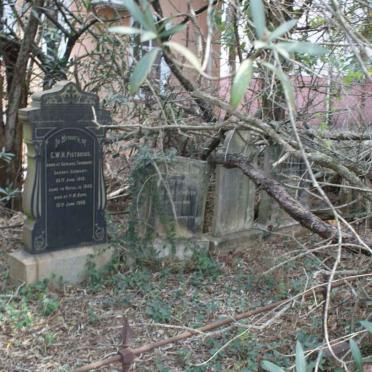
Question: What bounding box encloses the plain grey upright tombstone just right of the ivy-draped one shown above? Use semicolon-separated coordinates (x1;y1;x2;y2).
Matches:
212;131;256;236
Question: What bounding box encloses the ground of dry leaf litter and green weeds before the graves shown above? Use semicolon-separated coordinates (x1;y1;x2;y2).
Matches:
0;205;372;372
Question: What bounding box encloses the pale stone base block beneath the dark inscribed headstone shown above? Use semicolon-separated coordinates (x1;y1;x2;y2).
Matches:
8;244;113;284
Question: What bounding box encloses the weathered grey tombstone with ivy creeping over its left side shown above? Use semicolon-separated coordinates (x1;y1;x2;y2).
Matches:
141;156;209;258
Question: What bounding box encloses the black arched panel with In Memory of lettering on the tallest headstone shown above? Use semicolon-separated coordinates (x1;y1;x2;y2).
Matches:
45;128;95;245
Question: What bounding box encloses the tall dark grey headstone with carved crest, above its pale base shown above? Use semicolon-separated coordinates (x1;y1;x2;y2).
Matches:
20;81;110;253
